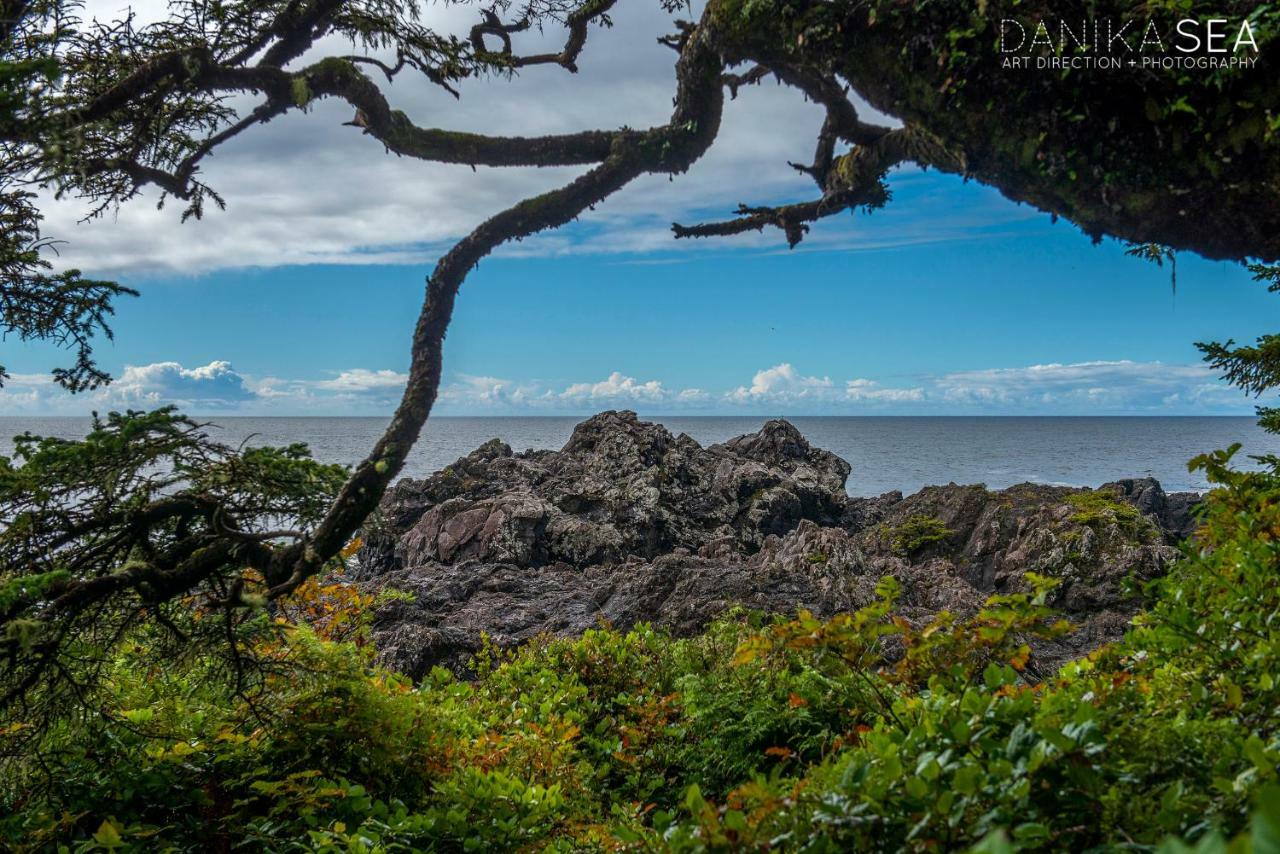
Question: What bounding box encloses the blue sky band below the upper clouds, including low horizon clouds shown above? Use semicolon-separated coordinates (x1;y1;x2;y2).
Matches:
4;167;1276;415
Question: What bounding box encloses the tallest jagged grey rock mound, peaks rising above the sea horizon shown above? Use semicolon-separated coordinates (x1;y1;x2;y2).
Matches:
360;412;849;576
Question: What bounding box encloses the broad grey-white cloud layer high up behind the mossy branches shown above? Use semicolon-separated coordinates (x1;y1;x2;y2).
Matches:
30;0;1033;275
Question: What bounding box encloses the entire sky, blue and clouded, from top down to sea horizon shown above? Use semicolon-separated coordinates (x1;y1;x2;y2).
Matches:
0;0;1280;415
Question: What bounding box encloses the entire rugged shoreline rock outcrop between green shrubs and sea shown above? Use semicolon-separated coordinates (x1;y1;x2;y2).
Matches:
357;411;1199;677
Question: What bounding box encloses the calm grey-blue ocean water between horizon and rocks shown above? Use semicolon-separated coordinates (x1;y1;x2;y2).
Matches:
0;415;1280;495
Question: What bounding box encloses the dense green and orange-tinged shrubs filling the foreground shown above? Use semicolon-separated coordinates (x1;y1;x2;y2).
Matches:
0;437;1280;851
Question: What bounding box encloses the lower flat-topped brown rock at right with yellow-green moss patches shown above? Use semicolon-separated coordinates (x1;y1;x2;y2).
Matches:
839;479;1198;668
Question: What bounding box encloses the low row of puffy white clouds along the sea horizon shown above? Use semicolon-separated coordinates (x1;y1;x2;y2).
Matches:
0;360;1253;415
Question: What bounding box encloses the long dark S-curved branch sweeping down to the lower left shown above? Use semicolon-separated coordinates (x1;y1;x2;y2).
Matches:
0;5;724;708
